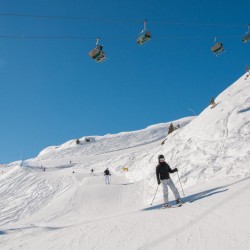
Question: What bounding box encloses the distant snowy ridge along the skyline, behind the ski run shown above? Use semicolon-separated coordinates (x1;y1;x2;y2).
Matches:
35;117;193;160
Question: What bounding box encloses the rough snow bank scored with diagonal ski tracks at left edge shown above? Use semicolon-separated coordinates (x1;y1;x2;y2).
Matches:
0;167;74;226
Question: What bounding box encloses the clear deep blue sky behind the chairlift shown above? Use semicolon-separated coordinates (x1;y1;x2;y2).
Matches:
0;0;250;163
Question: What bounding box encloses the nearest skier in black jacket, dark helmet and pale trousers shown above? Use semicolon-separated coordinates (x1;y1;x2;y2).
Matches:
156;155;183;208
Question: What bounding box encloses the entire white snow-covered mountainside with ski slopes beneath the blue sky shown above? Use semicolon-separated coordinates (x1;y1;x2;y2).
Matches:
0;75;250;250
